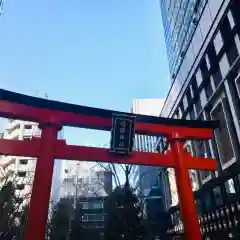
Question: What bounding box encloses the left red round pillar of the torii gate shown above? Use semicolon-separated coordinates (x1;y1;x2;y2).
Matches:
24;126;58;240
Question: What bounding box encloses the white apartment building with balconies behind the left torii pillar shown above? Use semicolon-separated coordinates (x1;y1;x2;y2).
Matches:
0;120;62;207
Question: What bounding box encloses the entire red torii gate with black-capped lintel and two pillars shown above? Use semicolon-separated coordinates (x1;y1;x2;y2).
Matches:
0;90;217;240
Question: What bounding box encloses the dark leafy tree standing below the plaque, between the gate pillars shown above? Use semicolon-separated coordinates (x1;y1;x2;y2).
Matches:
104;184;144;240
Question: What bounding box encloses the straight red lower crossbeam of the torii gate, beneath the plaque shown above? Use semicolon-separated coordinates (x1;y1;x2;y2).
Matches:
0;138;216;171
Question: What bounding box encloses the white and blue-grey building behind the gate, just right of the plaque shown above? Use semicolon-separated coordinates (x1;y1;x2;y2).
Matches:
131;99;164;197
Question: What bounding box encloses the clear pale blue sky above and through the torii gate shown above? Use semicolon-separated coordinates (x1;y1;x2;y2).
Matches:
0;0;170;145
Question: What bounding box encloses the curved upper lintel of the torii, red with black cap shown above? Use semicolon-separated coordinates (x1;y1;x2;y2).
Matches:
0;89;218;139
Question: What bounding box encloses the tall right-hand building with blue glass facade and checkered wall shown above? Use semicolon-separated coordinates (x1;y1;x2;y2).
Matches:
160;0;240;210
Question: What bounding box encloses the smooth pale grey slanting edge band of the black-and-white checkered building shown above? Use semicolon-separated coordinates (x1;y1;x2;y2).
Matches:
161;0;231;117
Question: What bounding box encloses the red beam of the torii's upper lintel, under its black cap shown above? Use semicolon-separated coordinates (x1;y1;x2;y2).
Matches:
0;101;212;139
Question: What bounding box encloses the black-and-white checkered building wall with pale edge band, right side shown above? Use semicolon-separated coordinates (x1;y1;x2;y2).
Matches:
161;0;240;208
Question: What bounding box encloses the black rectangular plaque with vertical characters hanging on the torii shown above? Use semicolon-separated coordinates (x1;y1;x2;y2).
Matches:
110;114;136;155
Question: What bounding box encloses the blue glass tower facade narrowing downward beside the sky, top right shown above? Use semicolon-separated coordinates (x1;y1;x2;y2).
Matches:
160;0;207;79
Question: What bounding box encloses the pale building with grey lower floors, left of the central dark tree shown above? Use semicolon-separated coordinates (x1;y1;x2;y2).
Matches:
60;162;112;239
